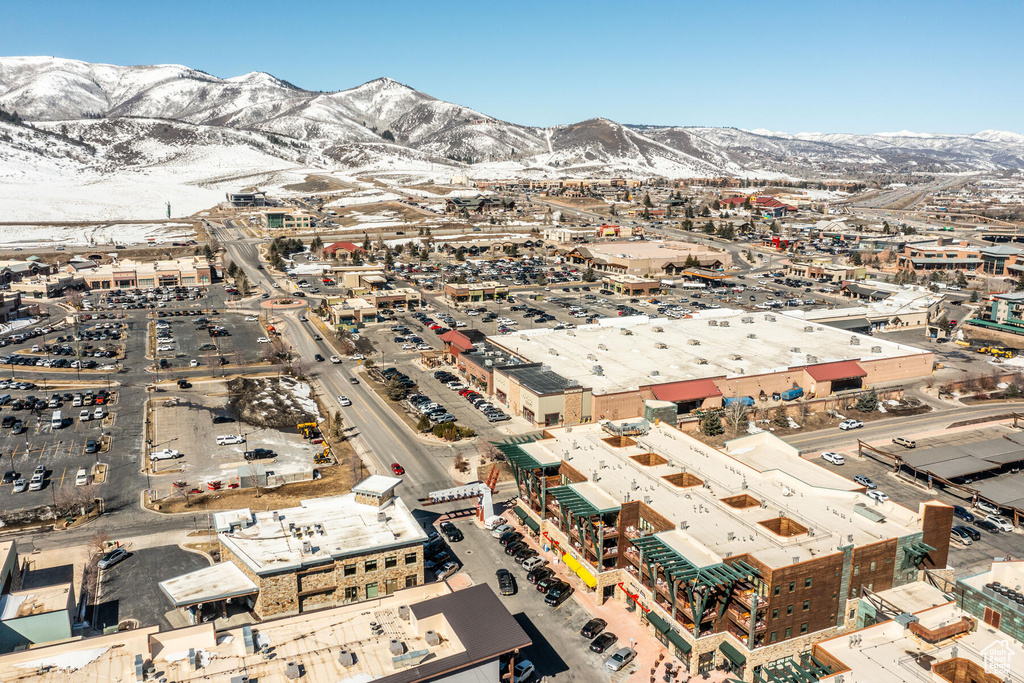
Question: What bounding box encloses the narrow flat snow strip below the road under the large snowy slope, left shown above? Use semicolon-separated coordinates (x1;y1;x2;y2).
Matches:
0;223;196;249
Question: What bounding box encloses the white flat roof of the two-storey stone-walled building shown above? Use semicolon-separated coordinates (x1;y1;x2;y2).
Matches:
219;493;427;574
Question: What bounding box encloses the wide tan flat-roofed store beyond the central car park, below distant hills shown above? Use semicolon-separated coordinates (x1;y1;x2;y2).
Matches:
565;240;732;278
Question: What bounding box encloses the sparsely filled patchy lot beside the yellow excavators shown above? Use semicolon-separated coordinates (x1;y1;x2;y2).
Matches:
151;381;323;494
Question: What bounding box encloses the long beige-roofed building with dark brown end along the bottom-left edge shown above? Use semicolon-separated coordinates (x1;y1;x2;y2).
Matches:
0;583;531;683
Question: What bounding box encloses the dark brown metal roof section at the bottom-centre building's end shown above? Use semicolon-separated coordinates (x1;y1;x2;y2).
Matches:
376;584;532;683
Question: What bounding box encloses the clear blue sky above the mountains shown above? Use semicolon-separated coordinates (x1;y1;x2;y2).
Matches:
0;0;1024;133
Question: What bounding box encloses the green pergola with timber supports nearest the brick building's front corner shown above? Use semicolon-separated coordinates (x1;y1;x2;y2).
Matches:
631;536;761;638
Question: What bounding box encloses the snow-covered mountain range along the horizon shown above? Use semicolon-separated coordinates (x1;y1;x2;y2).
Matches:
0;57;1024;196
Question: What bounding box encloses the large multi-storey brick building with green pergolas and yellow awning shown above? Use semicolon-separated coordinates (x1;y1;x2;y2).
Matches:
499;420;952;680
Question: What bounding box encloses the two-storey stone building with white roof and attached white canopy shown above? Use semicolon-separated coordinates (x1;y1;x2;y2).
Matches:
160;474;427;621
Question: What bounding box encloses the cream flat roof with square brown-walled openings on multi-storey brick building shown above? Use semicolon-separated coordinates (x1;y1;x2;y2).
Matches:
521;423;922;567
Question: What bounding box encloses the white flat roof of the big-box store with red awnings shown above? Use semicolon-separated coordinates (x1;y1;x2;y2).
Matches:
488;309;930;394
